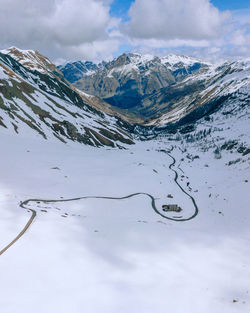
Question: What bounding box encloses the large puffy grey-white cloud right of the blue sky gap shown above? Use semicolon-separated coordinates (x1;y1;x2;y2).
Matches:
124;0;229;40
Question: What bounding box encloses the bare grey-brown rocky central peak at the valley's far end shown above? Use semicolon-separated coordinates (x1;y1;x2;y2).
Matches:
66;54;178;109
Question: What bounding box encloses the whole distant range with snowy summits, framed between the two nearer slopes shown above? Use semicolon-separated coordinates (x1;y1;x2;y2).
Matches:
59;53;208;115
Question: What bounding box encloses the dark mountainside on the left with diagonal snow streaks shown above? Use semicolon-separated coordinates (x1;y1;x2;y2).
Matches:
0;48;133;147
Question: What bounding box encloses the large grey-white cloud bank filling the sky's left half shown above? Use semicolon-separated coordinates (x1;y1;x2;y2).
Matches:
0;0;118;59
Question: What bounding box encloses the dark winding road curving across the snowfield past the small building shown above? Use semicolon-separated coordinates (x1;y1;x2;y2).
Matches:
0;147;199;255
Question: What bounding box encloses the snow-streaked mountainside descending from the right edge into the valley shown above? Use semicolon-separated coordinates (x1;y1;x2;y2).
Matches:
146;60;250;126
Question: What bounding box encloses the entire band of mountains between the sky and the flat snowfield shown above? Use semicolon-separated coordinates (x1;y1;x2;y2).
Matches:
0;47;250;147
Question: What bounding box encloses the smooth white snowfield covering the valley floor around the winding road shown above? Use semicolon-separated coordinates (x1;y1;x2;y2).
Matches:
0;125;250;313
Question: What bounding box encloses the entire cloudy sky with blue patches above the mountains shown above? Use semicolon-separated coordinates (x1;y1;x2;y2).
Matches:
0;0;250;63
